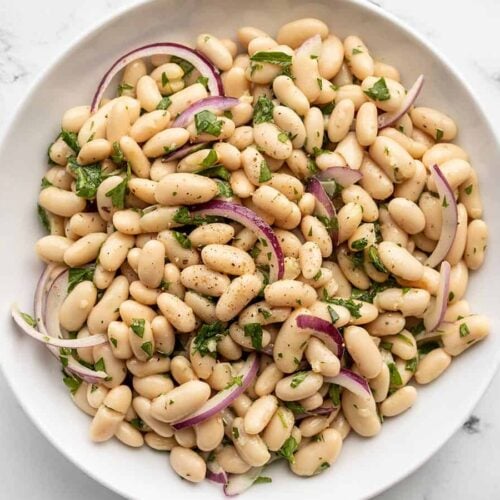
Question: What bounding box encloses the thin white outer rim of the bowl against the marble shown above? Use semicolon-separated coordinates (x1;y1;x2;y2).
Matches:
0;0;500;498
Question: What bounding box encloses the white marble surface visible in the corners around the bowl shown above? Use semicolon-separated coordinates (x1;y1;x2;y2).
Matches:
0;0;500;500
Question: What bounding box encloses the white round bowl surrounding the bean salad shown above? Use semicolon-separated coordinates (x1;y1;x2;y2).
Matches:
0;0;500;500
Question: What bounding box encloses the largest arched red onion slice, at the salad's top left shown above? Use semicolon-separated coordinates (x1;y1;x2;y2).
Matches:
90;42;224;113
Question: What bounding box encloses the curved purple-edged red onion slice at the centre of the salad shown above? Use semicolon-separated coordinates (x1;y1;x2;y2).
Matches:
193;200;285;283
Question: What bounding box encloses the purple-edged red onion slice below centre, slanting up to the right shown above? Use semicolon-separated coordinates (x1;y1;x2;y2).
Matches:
172;353;259;430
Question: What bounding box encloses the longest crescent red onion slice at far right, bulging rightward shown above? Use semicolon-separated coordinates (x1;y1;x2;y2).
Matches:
425;165;458;267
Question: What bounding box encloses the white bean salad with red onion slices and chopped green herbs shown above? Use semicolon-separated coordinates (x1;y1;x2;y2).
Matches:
12;19;489;495
